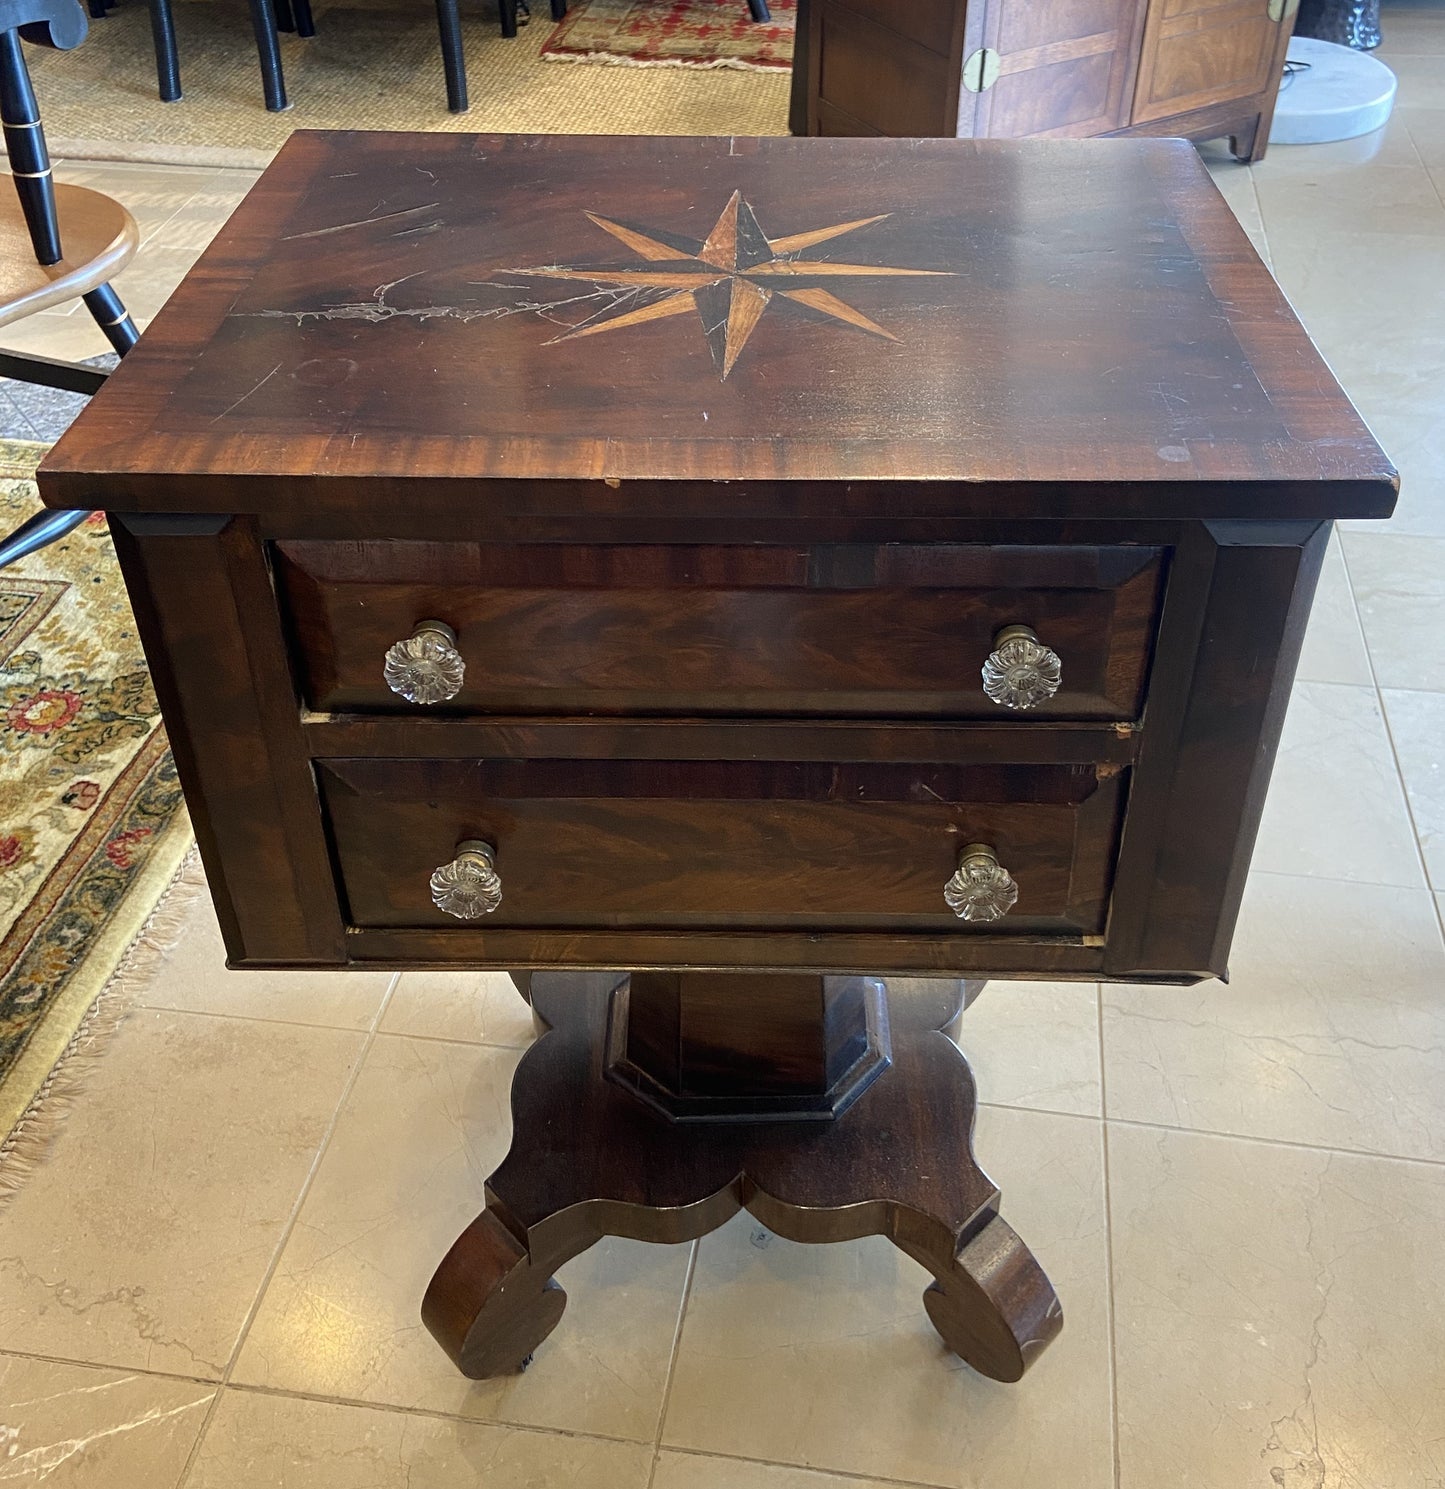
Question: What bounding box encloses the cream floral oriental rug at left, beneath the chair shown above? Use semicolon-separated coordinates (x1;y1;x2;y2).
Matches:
0;439;191;1154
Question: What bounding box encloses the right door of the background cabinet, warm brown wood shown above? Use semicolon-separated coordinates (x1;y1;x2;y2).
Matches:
1134;0;1280;124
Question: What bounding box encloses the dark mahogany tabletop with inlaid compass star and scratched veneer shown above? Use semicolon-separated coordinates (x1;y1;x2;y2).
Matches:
42;131;1394;517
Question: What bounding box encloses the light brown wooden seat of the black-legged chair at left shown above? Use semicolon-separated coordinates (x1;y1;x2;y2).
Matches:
0;185;140;326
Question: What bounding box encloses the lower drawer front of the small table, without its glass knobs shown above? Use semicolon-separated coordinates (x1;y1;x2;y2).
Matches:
317;759;1128;935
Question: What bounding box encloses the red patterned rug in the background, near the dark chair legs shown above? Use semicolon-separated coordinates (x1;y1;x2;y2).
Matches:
533;0;797;71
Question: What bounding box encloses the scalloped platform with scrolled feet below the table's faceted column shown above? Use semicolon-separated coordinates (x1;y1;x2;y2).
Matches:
422;972;1062;1380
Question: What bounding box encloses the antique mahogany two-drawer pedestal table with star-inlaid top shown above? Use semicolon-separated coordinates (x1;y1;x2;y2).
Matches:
40;133;1394;1380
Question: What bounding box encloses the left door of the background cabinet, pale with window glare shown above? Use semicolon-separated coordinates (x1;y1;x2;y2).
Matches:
961;0;1144;138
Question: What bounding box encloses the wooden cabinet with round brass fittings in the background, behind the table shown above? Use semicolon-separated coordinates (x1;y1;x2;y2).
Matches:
793;0;1295;159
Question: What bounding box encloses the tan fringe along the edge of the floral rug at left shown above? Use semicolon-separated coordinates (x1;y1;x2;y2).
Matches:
0;843;206;1205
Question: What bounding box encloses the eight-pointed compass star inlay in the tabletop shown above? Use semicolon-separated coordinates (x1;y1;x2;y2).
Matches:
488;192;950;378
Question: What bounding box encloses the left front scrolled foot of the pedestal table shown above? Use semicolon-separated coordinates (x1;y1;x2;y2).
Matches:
422;1209;580;1380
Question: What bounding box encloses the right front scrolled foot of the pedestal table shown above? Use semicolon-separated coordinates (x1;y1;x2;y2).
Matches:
924;1215;1064;1382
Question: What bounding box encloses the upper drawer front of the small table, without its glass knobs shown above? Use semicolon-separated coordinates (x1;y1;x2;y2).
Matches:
276;541;1163;719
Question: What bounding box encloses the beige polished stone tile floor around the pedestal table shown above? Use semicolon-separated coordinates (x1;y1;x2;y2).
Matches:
0;6;1445;1489
